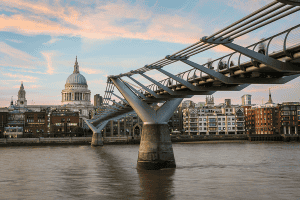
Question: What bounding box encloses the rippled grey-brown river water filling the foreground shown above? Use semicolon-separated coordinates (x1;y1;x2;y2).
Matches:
0;142;300;200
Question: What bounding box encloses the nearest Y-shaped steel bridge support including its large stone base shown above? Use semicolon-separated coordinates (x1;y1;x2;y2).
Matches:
111;78;183;170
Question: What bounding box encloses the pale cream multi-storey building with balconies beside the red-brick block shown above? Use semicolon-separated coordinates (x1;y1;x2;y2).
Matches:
183;97;245;135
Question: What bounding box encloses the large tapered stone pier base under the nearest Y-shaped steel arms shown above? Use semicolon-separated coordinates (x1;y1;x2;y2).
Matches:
137;122;176;170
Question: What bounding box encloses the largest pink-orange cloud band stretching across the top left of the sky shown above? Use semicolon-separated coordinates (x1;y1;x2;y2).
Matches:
0;0;202;44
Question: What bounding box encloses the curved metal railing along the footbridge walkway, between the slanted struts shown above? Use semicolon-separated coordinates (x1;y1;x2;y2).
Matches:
140;25;300;94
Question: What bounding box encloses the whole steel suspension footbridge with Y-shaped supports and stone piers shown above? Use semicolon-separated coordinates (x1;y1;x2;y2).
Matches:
85;0;300;169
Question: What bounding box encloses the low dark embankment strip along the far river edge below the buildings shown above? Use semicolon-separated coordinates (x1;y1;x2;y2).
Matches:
0;135;300;147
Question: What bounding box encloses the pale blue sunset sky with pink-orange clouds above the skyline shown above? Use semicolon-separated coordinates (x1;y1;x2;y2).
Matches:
0;0;300;107
